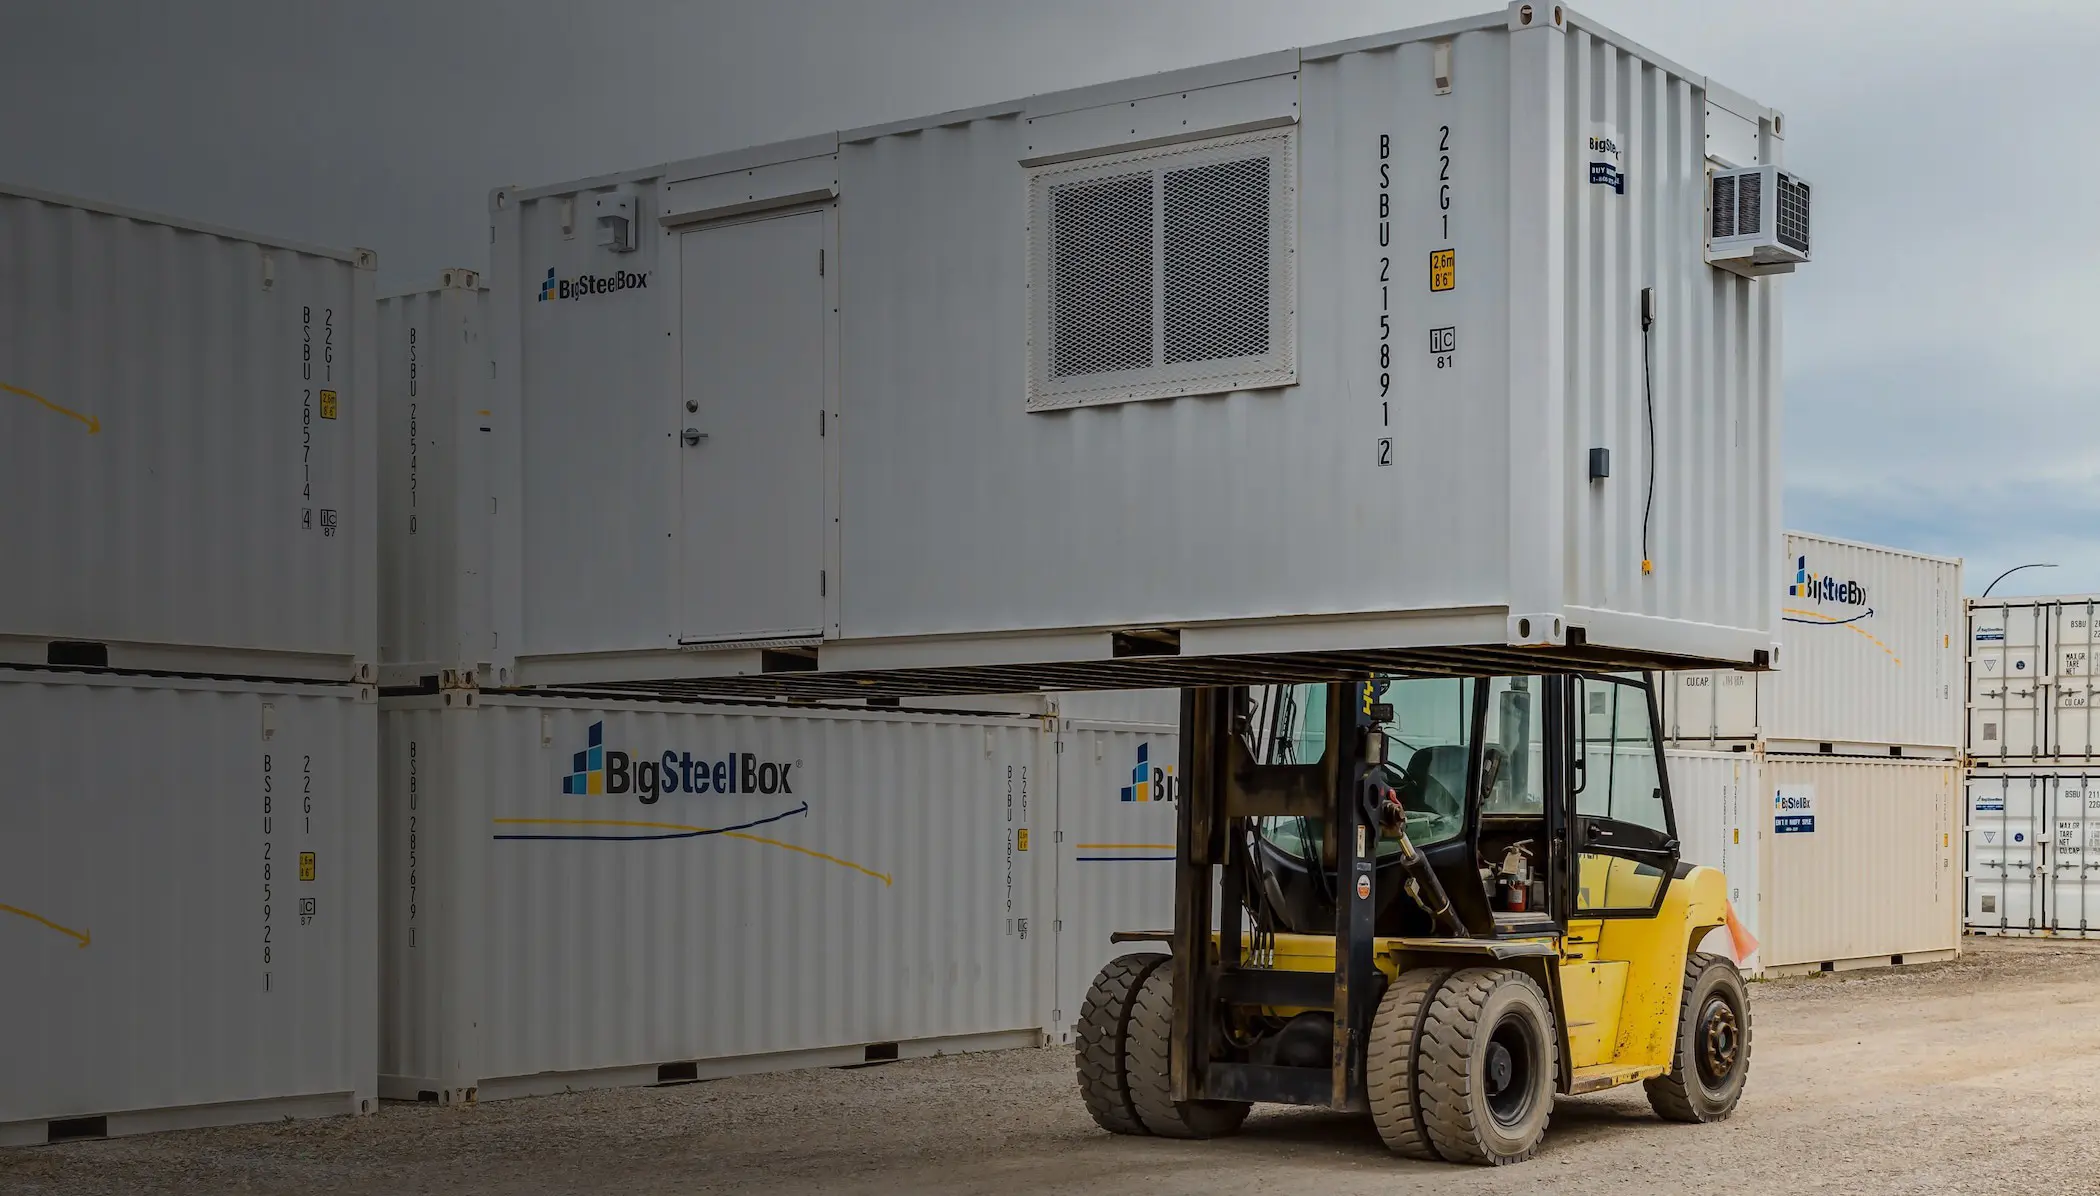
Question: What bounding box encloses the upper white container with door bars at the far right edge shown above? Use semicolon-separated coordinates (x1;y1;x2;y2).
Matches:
1968;594;2100;768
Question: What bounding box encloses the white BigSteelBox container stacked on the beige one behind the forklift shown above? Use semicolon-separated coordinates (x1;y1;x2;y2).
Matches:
1661;531;1964;755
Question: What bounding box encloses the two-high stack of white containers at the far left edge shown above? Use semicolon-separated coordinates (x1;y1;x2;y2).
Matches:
0;187;378;1144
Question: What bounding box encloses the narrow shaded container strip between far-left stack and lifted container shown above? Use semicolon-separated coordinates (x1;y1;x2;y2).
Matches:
378;271;493;684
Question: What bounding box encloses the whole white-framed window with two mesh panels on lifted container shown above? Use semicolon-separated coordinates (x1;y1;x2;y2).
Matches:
1029;130;1296;409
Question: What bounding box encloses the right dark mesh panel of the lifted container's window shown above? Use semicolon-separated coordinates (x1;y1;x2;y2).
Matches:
1159;155;1271;363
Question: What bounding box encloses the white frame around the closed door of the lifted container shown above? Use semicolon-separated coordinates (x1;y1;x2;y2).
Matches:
657;196;844;648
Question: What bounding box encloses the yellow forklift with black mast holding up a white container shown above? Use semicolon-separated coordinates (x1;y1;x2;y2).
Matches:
1077;674;1749;1165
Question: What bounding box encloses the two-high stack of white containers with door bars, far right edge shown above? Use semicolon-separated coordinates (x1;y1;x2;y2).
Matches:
1964;594;2100;938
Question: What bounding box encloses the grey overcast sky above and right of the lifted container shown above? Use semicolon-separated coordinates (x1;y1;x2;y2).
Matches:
0;0;2100;594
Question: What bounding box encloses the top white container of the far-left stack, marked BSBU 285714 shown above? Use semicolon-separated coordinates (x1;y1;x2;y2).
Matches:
0;187;378;680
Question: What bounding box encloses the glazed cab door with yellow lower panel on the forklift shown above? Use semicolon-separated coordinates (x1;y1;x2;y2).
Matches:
1569;678;1678;919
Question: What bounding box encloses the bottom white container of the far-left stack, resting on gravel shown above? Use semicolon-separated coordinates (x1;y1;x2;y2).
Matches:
0;671;378;1146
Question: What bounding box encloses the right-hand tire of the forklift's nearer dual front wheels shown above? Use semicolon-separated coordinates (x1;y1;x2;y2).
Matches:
1415;967;1560;1167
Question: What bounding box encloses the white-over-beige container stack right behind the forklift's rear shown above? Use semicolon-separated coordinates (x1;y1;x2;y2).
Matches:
1663;533;1964;974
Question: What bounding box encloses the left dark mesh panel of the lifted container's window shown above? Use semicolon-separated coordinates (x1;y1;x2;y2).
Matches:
1050;172;1153;378
